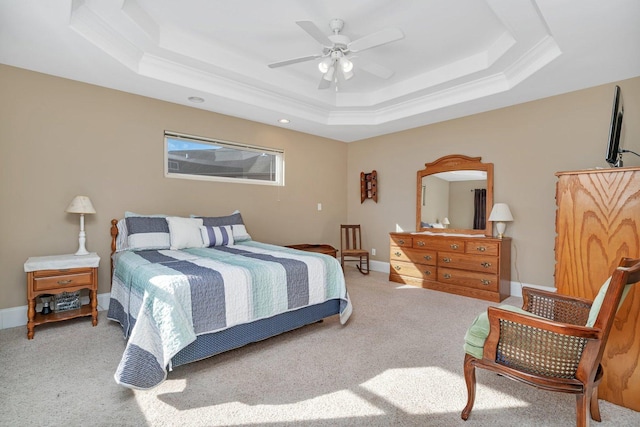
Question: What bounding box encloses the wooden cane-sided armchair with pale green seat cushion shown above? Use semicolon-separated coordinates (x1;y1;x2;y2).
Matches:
462;258;640;427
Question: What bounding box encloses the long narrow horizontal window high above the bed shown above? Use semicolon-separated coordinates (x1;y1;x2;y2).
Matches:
164;132;284;186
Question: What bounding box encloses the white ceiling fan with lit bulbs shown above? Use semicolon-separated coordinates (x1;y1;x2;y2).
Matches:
269;19;404;89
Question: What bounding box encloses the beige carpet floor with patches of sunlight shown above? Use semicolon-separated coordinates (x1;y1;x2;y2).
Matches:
0;269;640;427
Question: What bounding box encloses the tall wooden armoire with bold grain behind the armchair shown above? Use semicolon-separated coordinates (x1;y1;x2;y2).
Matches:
555;167;640;411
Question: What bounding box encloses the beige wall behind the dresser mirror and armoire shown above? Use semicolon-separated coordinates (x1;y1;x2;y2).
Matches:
347;78;640;286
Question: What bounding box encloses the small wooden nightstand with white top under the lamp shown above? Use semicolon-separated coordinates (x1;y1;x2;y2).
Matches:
24;252;100;339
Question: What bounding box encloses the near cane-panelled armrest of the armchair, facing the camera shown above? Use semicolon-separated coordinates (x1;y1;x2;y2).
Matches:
483;307;601;378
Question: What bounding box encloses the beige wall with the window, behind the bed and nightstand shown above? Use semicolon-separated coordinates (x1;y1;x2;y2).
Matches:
0;65;347;309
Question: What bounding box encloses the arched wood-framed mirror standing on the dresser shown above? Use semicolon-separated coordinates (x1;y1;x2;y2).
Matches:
416;154;493;236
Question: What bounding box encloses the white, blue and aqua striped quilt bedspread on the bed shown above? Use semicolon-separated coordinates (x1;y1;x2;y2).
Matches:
108;241;352;389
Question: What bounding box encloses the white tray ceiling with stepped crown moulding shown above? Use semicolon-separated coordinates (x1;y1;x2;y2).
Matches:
0;0;640;142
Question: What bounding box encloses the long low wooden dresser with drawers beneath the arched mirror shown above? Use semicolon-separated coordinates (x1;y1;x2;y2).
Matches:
389;233;511;302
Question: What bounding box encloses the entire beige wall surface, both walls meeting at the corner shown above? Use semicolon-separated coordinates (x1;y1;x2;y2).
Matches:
0;65;640;309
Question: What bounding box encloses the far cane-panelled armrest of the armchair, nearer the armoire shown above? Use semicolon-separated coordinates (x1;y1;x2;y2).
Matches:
522;287;592;326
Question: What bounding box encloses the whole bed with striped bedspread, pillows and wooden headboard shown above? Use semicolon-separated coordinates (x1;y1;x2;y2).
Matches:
107;212;352;389
